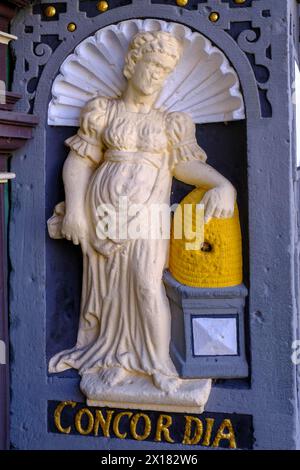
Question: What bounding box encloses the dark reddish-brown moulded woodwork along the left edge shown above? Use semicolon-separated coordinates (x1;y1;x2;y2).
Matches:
0;0;38;450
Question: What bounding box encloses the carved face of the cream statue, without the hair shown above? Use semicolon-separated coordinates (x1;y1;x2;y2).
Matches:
131;52;177;95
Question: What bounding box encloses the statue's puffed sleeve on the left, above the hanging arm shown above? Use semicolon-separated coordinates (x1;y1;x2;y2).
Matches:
65;97;108;166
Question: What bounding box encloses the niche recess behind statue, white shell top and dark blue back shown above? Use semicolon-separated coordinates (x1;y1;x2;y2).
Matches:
37;19;248;375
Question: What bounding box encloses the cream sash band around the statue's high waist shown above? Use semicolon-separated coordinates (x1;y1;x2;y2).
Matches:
104;149;164;169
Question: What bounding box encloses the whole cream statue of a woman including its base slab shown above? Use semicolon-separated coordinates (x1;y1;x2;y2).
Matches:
48;22;241;412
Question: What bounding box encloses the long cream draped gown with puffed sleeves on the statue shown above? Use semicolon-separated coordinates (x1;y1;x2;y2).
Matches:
49;97;206;377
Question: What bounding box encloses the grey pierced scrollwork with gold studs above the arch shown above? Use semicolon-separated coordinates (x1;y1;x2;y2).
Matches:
12;0;273;117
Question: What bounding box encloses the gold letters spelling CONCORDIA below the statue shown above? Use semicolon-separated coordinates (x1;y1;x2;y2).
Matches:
54;401;237;449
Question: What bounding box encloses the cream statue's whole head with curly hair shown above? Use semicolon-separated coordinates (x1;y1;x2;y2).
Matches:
124;31;182;95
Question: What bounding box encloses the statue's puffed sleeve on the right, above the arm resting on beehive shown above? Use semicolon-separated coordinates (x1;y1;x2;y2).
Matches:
167;112;207;170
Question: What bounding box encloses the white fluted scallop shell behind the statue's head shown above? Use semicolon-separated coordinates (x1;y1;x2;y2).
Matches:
48;19;245;126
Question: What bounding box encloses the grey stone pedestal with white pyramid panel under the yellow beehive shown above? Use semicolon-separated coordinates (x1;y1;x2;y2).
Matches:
164;271;248;378
